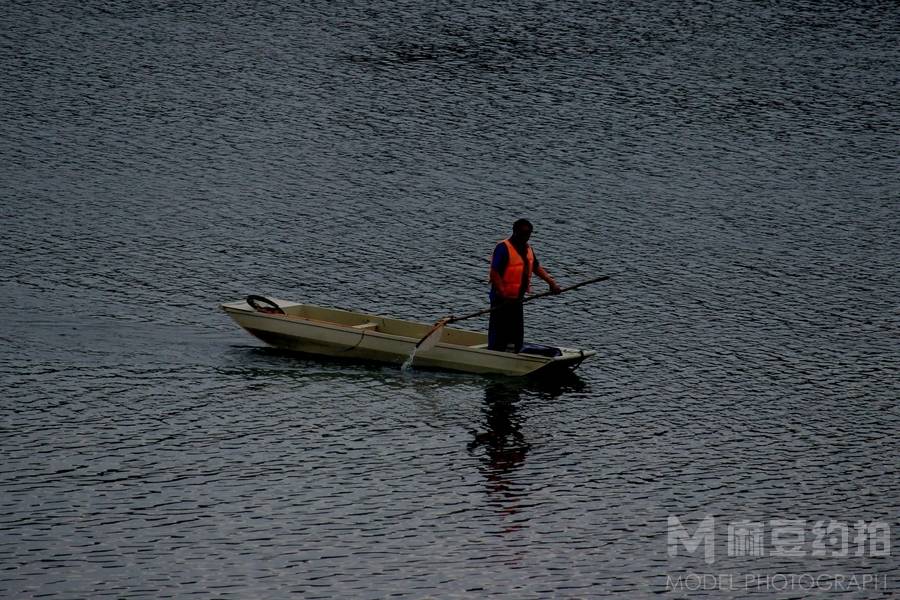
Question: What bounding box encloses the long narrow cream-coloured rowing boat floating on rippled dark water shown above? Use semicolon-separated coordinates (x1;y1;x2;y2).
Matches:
222;296;596;376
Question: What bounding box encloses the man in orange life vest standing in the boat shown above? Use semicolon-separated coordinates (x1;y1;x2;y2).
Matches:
488;219;561;352
